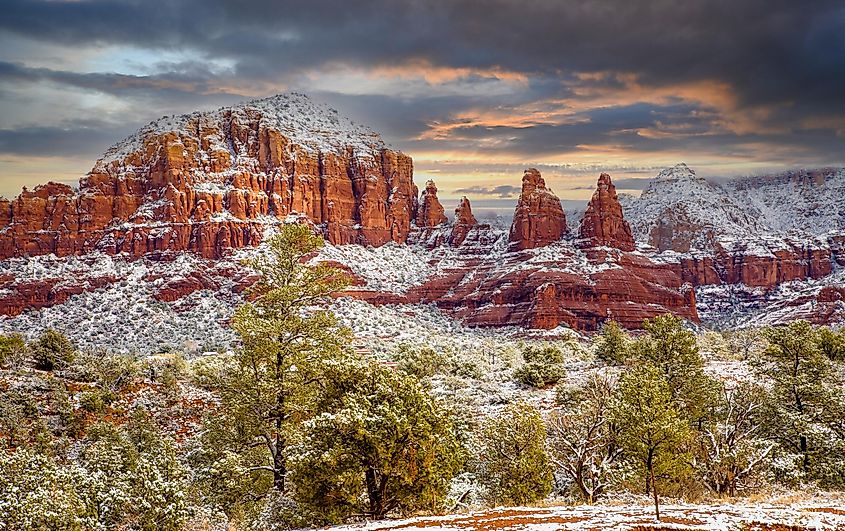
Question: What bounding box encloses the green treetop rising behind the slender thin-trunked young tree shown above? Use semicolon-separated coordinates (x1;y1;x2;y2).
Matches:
631;314;718;422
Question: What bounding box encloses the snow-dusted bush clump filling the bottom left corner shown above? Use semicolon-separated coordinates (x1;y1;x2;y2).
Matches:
0;415;189;531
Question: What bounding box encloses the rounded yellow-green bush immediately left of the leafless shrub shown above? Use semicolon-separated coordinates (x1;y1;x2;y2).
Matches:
478;403;552;505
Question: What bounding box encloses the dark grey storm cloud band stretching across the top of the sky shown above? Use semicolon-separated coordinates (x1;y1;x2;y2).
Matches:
6;0;845;112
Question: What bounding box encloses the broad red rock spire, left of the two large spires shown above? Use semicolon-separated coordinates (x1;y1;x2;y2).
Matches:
509;168;566;250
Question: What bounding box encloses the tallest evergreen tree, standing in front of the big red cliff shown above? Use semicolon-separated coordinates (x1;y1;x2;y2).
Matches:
197;224;351;510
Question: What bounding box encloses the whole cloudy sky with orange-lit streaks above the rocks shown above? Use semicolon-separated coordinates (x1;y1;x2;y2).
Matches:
0;0;845;202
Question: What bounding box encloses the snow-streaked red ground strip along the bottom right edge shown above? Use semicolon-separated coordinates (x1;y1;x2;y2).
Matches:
333;499;845;531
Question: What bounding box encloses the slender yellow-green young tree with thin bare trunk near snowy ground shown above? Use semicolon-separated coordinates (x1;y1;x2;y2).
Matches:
611;364;690;520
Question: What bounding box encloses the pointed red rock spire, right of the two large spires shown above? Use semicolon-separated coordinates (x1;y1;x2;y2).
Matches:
580;173;636;251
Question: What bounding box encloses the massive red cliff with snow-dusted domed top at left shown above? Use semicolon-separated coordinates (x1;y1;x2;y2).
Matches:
0;94;417;258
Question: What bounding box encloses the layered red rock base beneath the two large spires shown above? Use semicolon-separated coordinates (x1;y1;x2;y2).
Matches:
340;244;698;330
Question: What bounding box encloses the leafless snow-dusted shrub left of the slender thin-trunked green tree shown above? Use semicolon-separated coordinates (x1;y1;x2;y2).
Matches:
548;376;622;503
